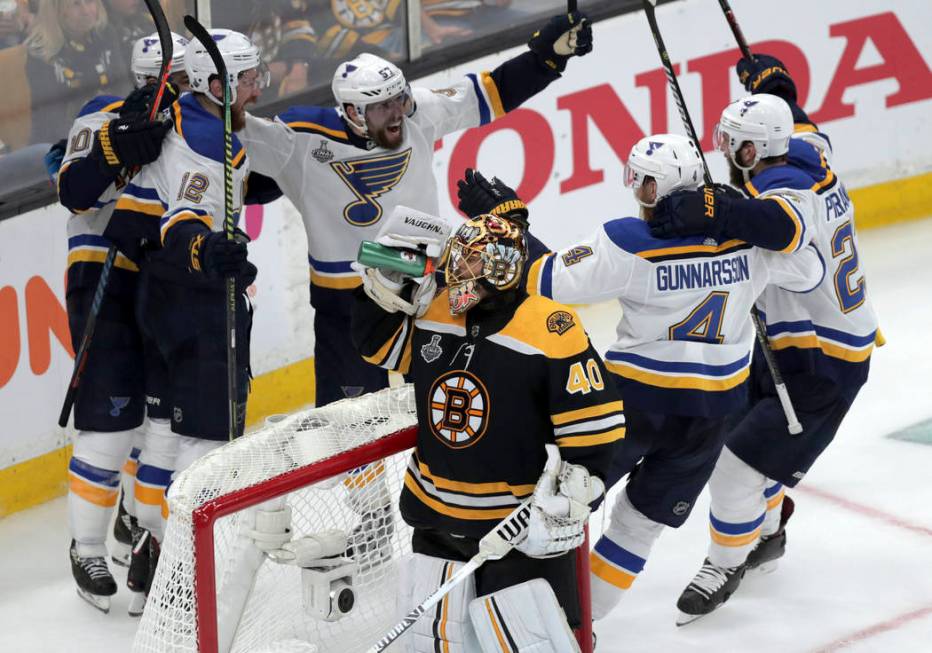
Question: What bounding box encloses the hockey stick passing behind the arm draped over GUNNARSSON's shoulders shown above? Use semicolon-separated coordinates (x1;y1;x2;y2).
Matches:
642;0;803;435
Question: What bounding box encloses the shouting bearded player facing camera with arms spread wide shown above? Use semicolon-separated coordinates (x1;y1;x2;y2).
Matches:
243;12;592;405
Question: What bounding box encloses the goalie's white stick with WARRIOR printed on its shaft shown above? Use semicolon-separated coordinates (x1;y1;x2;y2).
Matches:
366;444;560;653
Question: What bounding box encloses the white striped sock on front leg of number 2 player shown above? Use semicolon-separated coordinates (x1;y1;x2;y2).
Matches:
709;447;768;567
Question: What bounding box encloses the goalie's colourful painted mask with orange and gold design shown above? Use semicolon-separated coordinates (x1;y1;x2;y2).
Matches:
444;214;527;315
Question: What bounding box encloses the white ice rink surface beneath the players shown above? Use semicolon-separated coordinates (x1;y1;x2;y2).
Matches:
0;220;932;653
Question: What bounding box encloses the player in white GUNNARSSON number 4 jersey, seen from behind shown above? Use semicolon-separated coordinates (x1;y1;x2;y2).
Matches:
458;134;824;619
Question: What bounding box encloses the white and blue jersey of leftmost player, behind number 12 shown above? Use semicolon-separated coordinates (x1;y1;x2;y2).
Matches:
58;95;139;293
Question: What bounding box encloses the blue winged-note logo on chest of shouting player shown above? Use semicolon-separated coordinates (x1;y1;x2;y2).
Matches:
330;148;411;227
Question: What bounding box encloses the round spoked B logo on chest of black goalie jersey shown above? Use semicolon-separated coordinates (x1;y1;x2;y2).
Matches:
428;370;491;449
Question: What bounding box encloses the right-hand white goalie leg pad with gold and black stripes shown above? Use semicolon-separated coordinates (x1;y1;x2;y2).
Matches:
469;578;579;653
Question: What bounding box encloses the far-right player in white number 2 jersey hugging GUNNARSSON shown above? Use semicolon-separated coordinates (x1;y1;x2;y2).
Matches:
658;55;883;623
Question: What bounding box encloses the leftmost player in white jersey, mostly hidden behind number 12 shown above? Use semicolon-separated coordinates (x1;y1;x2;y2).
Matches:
57;34;187;612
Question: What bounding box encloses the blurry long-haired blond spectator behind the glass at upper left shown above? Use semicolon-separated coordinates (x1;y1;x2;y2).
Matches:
26;0;129;143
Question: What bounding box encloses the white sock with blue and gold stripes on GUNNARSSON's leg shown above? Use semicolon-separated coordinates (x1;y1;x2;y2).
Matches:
589;490;663;619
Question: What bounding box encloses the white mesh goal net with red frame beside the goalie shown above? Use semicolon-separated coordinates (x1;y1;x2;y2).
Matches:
133;386;416;653
